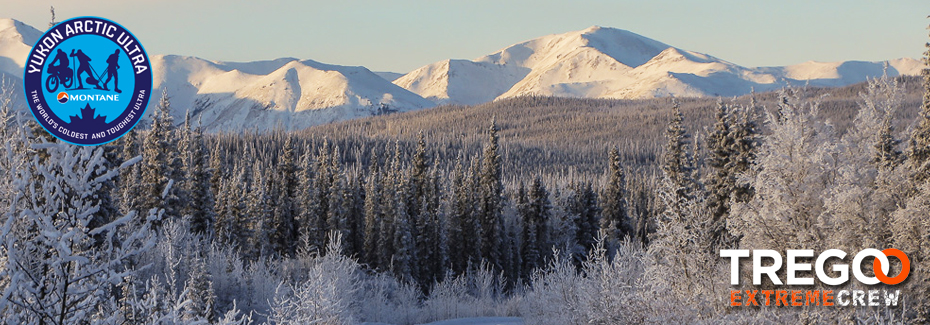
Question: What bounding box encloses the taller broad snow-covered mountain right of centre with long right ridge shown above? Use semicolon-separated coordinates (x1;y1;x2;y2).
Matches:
394;26;921;104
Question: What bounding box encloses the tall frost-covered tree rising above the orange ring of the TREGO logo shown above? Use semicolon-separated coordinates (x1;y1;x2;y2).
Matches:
821;75;906;249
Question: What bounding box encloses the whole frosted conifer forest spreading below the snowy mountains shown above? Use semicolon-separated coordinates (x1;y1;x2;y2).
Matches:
0;30;930;324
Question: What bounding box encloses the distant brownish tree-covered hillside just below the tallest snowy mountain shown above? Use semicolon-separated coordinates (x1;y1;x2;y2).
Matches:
301;77;921;174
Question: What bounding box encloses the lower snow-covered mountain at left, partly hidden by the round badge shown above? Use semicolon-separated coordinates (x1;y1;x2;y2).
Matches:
0;19;435;131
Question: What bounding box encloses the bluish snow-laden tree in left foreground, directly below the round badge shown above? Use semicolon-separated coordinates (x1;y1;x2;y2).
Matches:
0;143;161;324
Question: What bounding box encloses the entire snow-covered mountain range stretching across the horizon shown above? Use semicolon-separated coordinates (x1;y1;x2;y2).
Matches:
0;19;922;131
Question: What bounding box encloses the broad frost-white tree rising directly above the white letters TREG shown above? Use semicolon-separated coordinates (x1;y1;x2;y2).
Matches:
728;91;840;250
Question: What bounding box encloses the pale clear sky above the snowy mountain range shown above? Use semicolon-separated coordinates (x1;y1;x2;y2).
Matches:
0;0;930;72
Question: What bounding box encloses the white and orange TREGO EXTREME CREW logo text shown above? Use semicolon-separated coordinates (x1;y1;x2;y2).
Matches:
720;248;911;306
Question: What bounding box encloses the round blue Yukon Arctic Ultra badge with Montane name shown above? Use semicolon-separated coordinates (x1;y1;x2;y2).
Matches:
23;17;152;146
